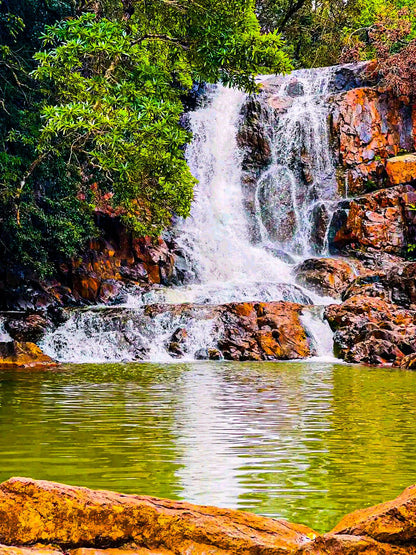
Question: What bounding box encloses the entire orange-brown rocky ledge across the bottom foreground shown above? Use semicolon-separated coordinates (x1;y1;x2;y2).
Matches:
0;478;416;555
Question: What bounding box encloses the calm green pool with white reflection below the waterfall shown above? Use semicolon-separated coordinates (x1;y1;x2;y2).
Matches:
0;362;416;531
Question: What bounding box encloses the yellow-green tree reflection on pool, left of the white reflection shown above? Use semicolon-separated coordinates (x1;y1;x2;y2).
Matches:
0;365;186;498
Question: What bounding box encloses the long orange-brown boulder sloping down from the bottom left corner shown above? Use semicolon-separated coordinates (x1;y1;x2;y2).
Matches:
0;478;315;555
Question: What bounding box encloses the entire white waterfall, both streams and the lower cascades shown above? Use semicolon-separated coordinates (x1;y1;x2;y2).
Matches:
42;68;344;362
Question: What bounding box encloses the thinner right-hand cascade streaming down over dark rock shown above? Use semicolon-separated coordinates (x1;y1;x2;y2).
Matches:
250;68;337;256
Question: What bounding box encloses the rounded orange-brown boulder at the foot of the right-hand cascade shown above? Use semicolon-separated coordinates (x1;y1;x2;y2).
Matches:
294;258;355;298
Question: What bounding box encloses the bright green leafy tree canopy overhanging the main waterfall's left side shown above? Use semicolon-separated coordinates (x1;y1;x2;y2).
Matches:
33;0;291;235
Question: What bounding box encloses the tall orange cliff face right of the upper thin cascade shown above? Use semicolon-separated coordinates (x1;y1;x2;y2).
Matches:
331;87;416;195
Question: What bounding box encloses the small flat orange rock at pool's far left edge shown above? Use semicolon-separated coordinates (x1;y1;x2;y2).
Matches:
0;341;57;370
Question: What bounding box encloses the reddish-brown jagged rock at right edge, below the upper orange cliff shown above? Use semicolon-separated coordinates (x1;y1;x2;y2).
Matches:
333;185;416;255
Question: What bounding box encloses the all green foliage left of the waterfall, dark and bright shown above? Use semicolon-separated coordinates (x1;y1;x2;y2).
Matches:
0;0;291;273
